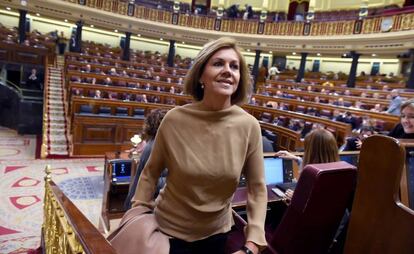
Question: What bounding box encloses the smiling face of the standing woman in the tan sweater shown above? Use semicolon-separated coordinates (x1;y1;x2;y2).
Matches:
200;48;240;104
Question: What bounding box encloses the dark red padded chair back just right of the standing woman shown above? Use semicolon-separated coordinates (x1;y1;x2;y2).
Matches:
269;161;357;254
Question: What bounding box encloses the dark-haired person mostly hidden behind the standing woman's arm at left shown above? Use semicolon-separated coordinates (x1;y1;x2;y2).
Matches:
124;109;168;210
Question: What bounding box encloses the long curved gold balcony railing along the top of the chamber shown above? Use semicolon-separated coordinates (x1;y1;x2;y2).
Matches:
64;0;414;36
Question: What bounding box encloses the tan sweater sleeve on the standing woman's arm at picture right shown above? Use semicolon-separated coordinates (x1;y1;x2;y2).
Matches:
244;122;267;249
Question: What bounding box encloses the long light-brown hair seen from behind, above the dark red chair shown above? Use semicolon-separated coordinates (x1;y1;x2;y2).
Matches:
302;129;339;168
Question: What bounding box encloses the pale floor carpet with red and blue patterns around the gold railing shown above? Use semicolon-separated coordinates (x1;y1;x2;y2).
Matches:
0;127;104;253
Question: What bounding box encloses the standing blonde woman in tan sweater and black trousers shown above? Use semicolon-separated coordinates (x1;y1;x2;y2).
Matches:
133;38;267;254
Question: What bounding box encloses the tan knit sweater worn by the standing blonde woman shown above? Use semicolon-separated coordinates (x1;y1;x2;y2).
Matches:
133;102;267;246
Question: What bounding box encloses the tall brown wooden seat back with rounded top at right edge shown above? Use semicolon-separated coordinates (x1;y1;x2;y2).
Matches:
344;135;414;254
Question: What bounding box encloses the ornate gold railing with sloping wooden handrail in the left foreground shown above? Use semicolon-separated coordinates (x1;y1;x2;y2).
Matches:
42;165;116;254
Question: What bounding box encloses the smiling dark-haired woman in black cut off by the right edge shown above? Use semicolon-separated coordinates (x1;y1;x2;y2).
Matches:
388;99;414;139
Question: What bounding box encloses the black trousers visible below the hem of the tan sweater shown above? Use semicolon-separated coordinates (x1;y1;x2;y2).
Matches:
170;233;228;254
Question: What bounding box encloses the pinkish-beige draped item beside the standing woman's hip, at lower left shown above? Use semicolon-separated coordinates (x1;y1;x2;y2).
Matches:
107;206;170;254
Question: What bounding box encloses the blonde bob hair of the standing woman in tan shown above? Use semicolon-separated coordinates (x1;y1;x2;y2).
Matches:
184;37;251;105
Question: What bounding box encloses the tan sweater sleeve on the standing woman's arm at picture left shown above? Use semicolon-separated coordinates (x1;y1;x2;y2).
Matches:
132;123;167;208
